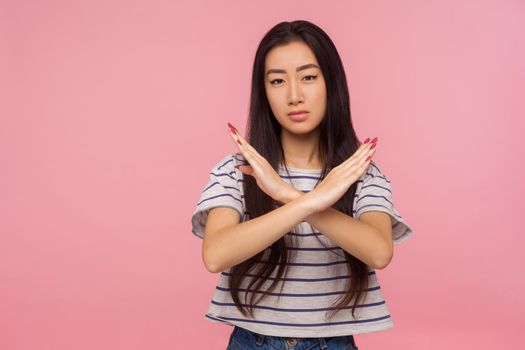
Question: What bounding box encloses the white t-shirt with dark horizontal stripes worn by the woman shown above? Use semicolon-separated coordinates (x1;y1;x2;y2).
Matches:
191;153;412;337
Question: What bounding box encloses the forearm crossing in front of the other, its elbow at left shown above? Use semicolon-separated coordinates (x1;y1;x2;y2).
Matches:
204;197;313;272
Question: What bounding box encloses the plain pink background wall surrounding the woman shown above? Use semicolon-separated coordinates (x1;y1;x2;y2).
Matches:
0;0;525;350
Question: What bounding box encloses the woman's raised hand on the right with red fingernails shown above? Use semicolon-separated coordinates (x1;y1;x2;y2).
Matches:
305;138;377;212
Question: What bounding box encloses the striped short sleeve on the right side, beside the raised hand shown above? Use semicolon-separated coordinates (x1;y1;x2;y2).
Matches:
354;161;412;245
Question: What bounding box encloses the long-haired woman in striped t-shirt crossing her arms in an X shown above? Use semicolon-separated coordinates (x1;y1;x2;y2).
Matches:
192;21;412;349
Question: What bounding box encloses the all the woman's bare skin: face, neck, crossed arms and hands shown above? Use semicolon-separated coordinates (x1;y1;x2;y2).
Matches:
202;43;393;272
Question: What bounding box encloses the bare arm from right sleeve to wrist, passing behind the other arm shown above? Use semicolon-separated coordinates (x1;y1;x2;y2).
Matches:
280;189;393;269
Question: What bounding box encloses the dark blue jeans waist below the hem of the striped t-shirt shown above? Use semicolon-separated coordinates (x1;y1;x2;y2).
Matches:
226;326;357;350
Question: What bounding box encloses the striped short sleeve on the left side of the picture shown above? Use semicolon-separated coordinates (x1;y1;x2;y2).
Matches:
191;154;244;238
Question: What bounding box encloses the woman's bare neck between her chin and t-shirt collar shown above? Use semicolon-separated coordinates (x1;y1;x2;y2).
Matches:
281;129;322;169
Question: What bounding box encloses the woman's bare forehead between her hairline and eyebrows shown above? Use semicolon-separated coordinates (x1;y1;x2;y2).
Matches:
264;42;319;71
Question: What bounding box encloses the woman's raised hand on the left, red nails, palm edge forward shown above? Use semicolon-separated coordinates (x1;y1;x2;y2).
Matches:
228;123;296;203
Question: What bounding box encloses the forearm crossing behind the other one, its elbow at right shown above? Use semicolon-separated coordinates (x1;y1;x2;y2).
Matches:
281;191;389;269
